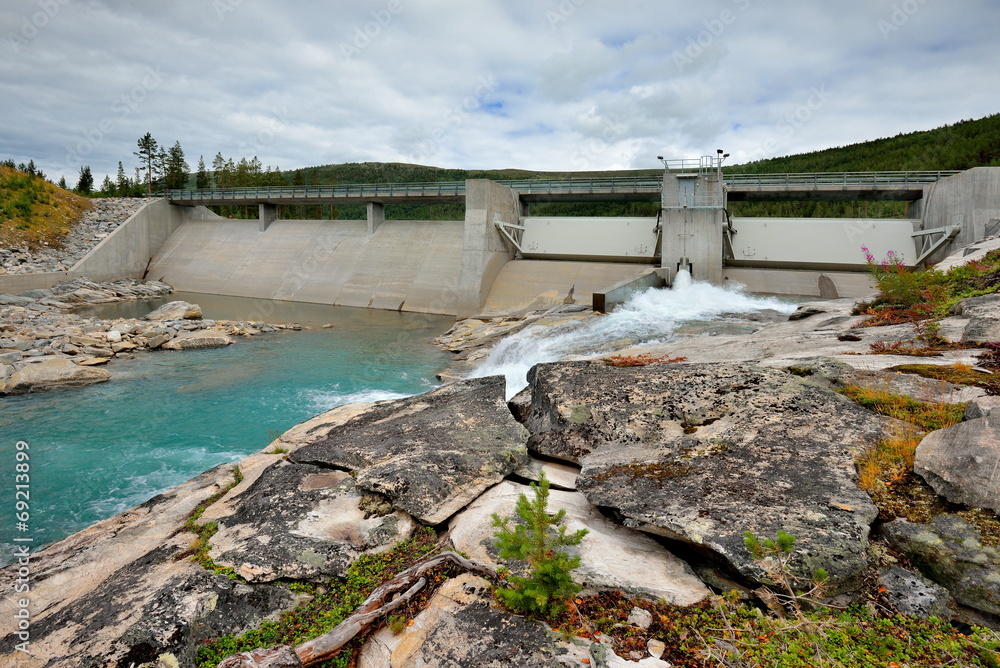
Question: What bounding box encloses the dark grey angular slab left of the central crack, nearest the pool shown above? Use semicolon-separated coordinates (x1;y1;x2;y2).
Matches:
290;376;528;524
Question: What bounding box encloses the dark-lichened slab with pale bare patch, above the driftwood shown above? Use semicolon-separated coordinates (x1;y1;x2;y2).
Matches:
209;461;416;582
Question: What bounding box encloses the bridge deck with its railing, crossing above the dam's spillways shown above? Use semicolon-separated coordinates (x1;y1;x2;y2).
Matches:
166;171;958;206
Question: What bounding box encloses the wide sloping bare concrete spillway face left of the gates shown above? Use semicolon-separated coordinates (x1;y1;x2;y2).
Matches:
148;219;463;315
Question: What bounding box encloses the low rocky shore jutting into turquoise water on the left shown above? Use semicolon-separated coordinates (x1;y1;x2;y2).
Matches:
0;279;301;395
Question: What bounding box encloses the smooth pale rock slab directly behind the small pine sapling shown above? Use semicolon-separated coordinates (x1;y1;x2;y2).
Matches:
449;481;710;605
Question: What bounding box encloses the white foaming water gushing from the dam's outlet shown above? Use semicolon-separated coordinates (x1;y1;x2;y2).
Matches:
470;270;795;399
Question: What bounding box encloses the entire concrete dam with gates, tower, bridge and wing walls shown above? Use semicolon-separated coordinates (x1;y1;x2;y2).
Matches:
0;163;1000;317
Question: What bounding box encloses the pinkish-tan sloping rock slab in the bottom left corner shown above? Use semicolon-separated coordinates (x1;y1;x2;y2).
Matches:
0;465;294;668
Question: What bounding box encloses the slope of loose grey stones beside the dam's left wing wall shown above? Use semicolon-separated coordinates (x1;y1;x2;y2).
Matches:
0;197;149;274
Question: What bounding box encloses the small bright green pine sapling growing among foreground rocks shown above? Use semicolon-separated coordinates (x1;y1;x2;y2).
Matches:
493;473;588;619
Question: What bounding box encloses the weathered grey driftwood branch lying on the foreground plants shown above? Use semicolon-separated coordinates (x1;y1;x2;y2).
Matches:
218;552;497;668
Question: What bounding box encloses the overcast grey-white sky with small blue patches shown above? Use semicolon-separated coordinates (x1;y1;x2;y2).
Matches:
0;0;1000;185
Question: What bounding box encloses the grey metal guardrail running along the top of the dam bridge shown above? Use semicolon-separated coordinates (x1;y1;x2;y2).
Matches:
166;170;959;201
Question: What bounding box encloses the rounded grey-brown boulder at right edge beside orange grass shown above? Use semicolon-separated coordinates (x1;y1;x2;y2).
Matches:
913;409;1000;511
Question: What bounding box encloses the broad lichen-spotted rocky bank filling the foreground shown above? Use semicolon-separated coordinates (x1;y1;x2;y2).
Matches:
0;250;1000;668
